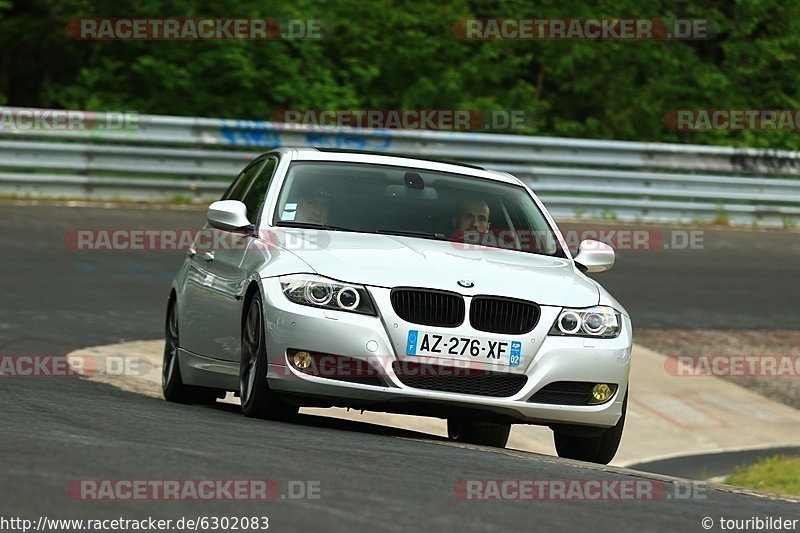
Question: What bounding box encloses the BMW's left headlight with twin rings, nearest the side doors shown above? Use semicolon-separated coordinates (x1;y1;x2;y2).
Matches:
279;274;376;315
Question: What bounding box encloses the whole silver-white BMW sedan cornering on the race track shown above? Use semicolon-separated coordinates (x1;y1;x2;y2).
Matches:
163;148;632;463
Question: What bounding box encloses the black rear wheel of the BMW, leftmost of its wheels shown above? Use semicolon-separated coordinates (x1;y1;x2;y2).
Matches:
161;298;222;404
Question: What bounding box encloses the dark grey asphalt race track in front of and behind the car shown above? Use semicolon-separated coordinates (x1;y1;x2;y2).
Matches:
0;204;800;531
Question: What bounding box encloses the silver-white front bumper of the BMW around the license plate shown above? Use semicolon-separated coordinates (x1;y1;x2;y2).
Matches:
262;278;632;427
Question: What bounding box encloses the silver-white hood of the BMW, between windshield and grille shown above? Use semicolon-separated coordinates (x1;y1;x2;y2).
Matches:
272;228;599;307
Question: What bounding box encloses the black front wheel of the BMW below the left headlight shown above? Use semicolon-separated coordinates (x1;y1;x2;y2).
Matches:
239;292;298;420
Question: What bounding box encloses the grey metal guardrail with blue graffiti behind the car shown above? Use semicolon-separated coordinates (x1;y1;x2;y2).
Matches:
0;107;800;227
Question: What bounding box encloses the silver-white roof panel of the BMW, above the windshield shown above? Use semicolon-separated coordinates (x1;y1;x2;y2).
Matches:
264;147;522;185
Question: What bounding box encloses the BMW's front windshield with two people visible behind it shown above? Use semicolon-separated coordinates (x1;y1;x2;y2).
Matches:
273;162;565;257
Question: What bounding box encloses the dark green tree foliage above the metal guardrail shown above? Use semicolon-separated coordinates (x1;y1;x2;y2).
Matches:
0;0;800;149
